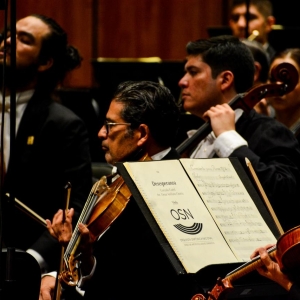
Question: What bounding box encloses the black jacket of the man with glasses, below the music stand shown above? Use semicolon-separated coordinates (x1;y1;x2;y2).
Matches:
78;149;199;300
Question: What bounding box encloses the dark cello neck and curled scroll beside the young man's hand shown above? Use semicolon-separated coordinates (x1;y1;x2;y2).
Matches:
176;63;299;158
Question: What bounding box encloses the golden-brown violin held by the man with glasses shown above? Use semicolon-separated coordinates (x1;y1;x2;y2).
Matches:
58;154;151;286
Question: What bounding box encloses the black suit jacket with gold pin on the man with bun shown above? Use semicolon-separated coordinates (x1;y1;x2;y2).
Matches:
2;93;92;269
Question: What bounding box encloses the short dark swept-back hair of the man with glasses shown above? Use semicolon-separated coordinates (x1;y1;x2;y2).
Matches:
114;81;180;147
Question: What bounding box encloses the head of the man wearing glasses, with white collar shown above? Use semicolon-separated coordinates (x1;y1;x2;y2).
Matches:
98;82;179;164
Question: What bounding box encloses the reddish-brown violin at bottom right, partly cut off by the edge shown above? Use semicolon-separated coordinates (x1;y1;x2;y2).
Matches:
192;226;300;300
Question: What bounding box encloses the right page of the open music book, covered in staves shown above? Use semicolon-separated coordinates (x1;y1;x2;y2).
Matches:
180;158;276;261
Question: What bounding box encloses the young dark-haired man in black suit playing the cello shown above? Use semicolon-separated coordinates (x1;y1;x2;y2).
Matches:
179;36;300;230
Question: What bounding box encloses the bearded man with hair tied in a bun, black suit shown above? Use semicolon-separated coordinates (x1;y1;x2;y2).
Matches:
0;15;92;272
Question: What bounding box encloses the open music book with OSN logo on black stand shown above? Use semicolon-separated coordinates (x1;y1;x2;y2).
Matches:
117;158;279;274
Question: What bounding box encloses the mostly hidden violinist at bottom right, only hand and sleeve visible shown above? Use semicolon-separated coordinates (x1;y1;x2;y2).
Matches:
250;245;300;300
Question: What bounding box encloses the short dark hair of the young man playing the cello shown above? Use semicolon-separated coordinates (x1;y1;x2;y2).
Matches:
186;35;255;93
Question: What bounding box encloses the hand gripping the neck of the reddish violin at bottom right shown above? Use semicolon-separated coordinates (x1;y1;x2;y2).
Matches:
250;245;293;291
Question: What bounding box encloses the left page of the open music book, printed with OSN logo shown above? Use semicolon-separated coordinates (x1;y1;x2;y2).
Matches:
124;160;239;273
